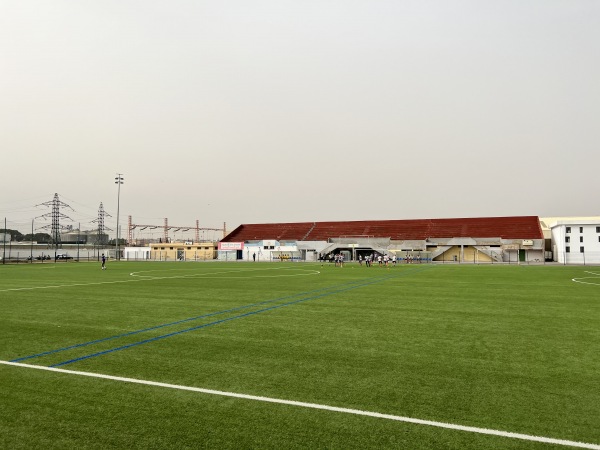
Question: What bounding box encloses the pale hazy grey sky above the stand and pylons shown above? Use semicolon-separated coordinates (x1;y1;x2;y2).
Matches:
0;0;600;243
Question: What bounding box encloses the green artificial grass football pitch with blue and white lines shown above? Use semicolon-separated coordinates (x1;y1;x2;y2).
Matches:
0;262;600;449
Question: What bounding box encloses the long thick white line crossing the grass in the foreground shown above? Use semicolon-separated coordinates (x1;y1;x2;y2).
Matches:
0;361;600;450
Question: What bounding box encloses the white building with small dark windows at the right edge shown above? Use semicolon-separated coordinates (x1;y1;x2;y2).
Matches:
548;218;600;264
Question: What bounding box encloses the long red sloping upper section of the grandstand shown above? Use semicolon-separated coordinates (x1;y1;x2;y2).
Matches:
223;216;544;242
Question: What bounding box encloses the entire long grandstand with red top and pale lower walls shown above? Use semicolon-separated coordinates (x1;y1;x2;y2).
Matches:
221;216;545;263
